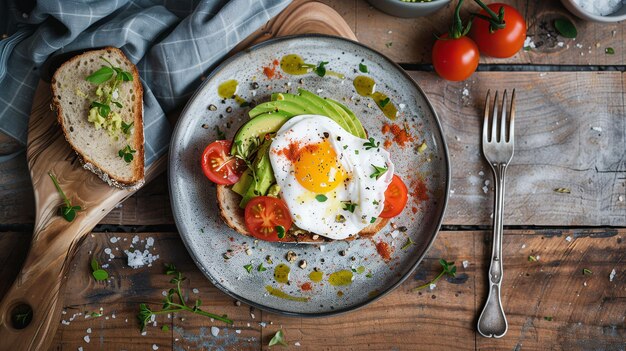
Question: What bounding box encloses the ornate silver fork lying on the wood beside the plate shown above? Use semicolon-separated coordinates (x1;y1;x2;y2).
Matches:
478;89;515;338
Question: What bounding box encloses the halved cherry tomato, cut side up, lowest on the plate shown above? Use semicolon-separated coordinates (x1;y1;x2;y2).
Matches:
244;196;292;241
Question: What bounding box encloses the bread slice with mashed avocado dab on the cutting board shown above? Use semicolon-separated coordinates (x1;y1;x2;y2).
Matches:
51;47;144;189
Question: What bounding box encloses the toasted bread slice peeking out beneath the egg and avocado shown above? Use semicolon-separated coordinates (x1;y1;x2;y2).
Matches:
217;185;389;243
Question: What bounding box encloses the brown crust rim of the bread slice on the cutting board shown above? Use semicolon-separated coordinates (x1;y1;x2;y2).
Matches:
51;47;145;190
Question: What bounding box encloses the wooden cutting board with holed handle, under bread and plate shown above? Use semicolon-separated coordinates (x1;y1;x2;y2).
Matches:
0;1;356;350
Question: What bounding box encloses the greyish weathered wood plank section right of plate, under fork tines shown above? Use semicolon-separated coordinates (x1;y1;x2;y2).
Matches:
411;72;626;226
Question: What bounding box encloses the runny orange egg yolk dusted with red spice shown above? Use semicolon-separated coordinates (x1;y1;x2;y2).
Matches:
294;140;346;194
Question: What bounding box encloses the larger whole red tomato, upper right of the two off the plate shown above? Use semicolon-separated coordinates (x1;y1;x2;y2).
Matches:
470;3;526;58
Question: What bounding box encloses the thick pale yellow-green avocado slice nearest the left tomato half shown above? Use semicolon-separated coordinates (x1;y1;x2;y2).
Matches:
230;111;292;156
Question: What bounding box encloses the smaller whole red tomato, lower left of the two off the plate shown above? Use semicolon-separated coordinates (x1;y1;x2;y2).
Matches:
433;34;480;81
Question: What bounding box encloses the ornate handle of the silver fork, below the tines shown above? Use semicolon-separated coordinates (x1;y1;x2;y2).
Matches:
478;163;509;338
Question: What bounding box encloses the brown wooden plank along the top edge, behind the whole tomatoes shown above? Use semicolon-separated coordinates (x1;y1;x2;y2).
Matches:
338;0;626;65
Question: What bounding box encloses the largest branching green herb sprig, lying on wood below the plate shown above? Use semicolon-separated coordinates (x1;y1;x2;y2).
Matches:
137;264;233;331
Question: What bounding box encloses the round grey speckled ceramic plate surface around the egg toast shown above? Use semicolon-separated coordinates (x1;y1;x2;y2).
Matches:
169;35;450;316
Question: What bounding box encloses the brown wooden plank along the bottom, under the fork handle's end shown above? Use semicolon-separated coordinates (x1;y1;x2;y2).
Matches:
30;229;626;350
